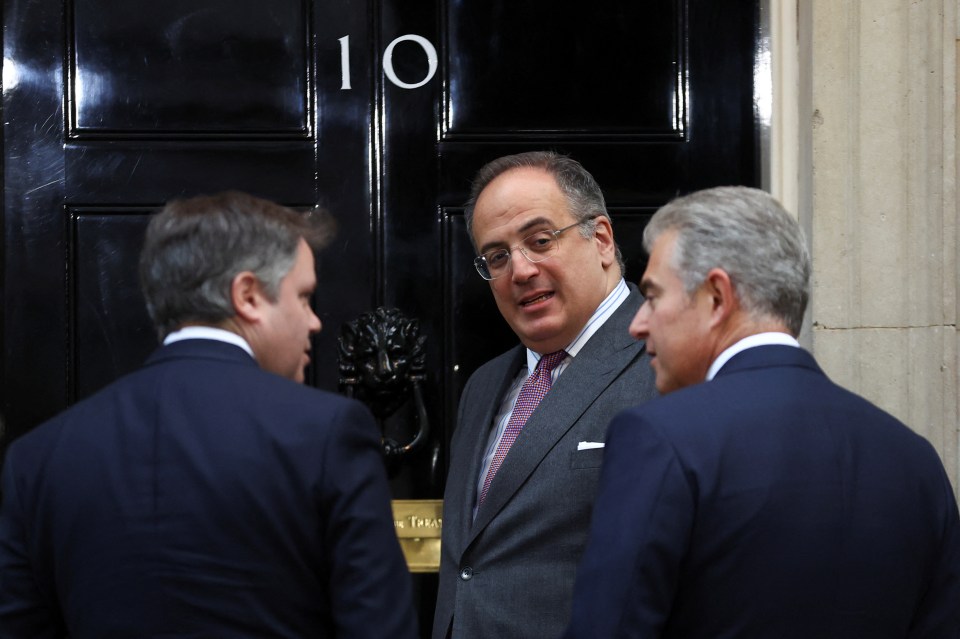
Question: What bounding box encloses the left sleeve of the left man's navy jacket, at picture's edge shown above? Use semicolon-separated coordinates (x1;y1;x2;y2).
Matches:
0;449;65;637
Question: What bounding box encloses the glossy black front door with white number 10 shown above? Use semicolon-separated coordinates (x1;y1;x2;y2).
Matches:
0;0;760;632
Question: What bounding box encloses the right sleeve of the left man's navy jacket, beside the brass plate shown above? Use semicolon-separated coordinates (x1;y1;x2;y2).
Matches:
320;402;417;639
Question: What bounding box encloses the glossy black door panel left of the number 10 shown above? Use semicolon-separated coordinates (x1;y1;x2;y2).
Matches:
66;0;313;139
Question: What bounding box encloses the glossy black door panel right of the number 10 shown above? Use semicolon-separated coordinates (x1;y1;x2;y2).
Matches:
444;0;687;143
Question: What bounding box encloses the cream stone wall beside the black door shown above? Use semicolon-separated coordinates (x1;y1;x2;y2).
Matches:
765;0;960;496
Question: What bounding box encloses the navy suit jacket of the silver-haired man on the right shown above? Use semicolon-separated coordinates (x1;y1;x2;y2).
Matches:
566;346;960;639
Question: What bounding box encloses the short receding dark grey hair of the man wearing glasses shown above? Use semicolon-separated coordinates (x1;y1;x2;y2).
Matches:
464;151;625;274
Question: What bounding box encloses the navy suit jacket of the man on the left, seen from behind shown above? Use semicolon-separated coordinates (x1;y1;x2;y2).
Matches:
0;340;416;639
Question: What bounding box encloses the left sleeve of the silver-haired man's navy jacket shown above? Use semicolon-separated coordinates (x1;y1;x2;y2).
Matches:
565;411;694;639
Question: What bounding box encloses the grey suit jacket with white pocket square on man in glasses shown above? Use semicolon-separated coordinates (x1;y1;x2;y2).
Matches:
433;287;656;639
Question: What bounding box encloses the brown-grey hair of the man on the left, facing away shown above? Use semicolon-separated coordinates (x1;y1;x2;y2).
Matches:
140;191;334;339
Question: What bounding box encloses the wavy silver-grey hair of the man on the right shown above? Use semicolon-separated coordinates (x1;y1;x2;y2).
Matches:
643;186;810;336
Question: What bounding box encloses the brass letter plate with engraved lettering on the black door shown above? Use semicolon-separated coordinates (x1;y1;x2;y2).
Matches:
391;499;443;572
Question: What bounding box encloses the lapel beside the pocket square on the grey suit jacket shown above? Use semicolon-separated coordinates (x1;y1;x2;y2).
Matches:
468;290;643;543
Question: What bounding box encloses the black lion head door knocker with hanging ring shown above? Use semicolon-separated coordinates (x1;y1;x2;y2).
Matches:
339;307;430;476
